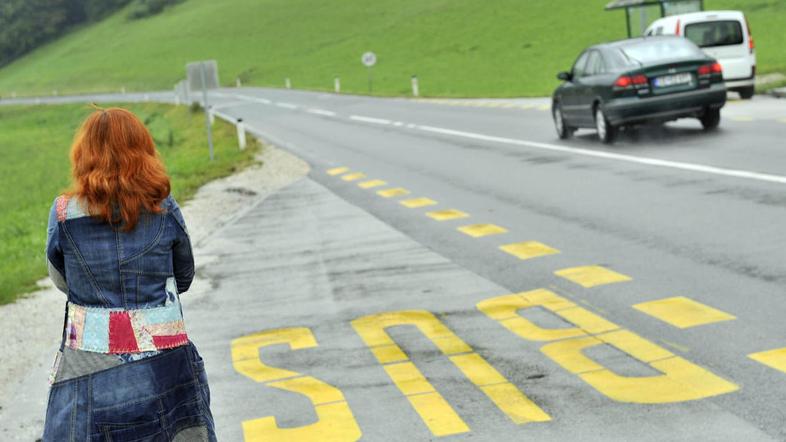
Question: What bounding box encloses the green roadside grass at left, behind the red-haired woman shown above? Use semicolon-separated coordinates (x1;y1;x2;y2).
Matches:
0;104;256;304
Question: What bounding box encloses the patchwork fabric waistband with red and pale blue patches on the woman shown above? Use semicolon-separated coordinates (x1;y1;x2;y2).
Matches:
65;302;188;353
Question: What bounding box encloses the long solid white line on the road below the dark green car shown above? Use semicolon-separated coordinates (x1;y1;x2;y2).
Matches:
417;125;786;184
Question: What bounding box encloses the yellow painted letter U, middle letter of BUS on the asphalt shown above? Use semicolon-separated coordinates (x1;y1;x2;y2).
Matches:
352;310;551;436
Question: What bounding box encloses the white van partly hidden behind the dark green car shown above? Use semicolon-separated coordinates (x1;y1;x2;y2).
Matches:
644;11;756;99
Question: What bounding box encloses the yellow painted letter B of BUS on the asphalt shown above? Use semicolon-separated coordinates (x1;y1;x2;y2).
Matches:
477;289;739;404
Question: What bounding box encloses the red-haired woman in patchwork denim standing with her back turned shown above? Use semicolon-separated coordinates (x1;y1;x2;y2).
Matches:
44;108;215;442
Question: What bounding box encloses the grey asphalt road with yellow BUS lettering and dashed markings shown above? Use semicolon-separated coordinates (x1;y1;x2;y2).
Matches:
6;88;786;440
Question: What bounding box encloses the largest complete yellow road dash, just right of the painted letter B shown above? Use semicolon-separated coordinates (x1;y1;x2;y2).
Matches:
633;296;737;328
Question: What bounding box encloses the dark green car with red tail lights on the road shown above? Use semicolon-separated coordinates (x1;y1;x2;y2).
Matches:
552;37;726;143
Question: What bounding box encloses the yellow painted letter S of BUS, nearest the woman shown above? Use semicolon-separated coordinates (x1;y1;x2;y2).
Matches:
232;328;361;442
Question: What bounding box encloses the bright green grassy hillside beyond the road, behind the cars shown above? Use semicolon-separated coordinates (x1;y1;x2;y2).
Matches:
0;0;786;97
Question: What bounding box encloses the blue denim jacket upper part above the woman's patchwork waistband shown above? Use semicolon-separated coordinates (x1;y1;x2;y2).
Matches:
46;196;194;309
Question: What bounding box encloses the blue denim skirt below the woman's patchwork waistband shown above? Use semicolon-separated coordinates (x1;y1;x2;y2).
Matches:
44;343;216;442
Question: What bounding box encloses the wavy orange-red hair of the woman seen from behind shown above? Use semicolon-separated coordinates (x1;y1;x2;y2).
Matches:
69;108;170;231
